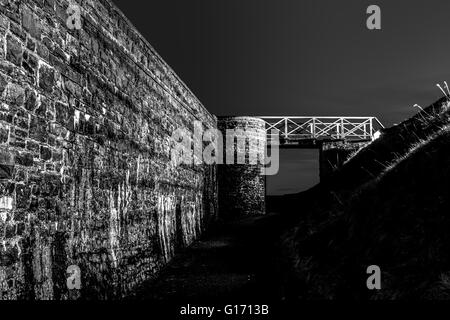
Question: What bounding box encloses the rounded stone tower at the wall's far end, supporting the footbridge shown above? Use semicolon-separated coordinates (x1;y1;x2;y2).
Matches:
218;117;266;220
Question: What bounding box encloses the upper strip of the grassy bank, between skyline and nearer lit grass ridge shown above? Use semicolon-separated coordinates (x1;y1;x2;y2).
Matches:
269;99;450;227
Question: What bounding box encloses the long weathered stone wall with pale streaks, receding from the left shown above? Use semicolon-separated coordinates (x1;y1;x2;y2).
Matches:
0;0;217;299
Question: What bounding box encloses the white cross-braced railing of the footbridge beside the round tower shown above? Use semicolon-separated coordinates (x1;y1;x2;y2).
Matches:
259;117;384;141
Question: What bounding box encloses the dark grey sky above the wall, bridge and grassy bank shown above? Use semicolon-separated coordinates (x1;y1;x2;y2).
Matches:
110;0;450;192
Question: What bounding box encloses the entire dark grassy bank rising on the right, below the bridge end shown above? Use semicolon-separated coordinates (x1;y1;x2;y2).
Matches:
285;96;450;299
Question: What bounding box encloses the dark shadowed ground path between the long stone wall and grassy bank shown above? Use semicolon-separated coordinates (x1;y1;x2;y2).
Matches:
132;215;282;303
